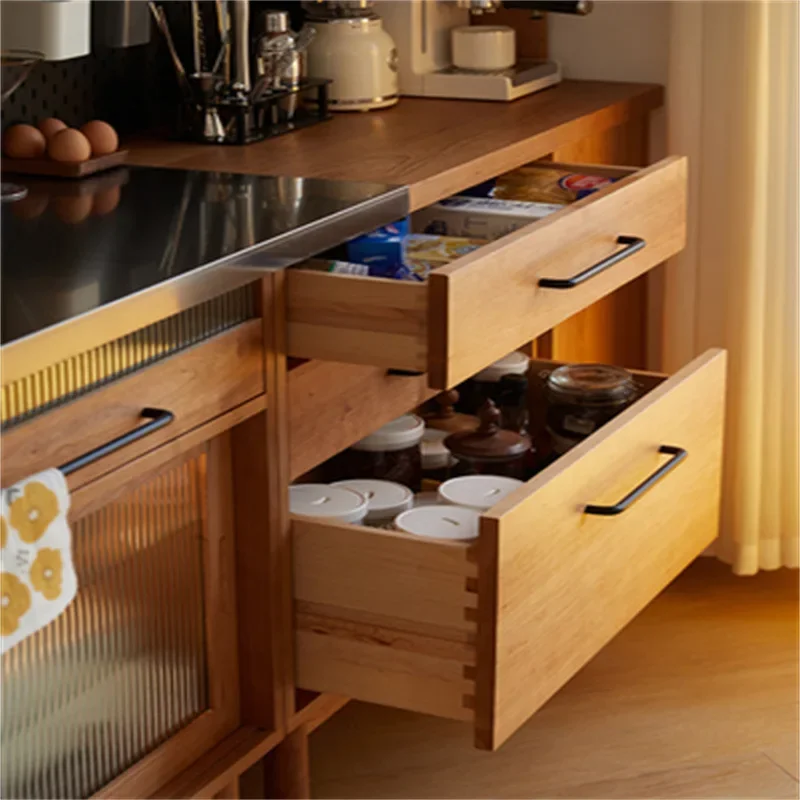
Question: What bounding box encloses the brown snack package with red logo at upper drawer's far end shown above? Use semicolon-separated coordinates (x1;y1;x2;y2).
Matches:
492;166;619;203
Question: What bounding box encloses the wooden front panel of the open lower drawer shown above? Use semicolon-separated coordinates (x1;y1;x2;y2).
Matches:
476;350;726;749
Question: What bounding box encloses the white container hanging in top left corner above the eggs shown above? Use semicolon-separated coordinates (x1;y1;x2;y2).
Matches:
0;0;91;61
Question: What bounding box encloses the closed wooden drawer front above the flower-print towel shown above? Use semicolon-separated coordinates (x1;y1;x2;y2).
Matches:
2;319;264;490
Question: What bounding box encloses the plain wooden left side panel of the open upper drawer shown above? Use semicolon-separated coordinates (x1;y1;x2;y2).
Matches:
286;269;428;372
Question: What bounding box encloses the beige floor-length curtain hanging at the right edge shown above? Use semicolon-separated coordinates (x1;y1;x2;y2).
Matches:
662;0;800;574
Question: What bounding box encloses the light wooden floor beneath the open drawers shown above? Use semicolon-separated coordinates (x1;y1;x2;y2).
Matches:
311;558;798;800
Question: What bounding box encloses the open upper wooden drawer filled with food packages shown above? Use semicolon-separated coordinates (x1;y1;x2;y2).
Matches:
287;157;686;389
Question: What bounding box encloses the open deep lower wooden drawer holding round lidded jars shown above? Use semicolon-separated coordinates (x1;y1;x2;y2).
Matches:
292;350;725;749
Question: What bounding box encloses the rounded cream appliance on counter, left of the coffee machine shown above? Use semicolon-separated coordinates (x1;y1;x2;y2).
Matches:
305;3;399;111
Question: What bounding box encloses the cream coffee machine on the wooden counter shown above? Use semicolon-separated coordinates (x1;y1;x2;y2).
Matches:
380;0;592;101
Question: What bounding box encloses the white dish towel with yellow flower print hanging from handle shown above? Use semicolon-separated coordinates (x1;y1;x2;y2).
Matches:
0;469;78;653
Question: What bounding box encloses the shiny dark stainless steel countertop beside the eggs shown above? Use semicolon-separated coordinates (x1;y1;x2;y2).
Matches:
0;167;408;382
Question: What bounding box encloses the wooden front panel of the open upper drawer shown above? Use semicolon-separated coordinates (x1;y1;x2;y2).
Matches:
428;157;687;388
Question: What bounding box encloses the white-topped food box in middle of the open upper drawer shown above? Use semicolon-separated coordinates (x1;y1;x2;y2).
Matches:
411;196;564;240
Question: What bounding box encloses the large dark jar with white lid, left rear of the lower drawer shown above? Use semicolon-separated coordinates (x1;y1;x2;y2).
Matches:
341;414;425;491
